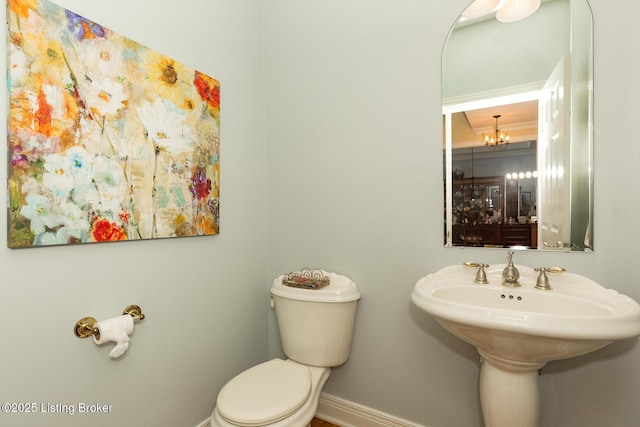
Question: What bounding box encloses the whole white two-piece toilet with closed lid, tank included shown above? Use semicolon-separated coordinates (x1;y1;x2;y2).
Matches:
211;270;360;427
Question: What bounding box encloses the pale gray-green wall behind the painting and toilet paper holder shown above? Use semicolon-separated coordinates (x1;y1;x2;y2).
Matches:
0;0;268;427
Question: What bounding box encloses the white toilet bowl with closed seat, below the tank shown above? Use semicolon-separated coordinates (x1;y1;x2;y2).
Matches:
211;359;331;427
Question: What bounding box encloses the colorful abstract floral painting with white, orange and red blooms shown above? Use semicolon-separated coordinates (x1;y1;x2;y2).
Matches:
7;0;220;248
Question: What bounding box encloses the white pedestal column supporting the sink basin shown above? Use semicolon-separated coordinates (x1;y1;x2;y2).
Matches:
479;351;545;427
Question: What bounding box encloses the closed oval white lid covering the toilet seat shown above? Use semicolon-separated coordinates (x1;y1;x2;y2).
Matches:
217;359;311;426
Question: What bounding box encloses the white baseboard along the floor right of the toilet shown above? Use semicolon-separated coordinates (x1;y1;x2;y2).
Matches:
316;393;424;427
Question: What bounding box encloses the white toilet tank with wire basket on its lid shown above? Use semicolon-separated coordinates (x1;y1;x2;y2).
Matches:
271;270;360;367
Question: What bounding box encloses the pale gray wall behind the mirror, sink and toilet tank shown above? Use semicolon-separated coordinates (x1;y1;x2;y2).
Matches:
264;0;640;427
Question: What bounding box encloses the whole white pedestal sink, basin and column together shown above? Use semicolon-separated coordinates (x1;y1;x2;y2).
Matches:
411;264;640;427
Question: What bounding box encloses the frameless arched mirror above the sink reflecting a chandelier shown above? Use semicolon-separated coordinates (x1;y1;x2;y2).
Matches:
442;0;593;251
